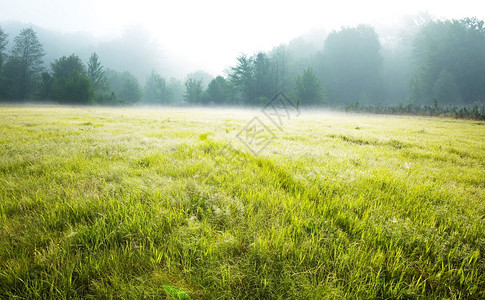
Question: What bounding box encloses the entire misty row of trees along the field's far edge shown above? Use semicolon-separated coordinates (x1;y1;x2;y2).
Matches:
0;18;485;108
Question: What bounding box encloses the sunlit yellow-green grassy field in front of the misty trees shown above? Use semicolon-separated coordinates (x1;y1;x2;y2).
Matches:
0;106;485;299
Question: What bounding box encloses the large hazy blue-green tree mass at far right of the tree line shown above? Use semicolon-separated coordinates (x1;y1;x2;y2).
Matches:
410;18;485;104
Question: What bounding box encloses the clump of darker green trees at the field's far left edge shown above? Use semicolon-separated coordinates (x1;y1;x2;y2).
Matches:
0;28;142;105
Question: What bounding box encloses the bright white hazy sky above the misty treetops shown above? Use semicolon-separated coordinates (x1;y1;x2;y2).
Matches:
0;0;485;74
